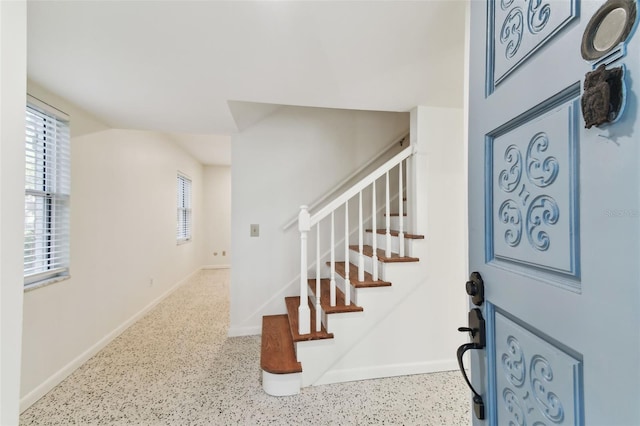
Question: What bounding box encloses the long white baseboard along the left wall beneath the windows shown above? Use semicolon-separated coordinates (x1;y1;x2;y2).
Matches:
20;268;202;413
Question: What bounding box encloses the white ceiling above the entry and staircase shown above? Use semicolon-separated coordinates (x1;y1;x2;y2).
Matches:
27;0;465;164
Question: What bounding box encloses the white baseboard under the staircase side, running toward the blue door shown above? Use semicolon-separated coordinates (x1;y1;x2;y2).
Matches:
313;359;458;386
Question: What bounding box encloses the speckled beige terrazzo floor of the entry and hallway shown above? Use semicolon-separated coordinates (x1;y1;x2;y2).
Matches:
20;270;470;426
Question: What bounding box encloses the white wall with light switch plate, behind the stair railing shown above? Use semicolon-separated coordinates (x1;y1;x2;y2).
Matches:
229;107;409;335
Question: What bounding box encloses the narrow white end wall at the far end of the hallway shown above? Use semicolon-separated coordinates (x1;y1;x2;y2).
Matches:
203;166;231;268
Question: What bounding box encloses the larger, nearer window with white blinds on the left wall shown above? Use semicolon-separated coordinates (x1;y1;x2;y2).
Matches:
24;97;70;286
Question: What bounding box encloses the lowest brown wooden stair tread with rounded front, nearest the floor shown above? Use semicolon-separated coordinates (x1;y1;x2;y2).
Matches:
260;314;302;374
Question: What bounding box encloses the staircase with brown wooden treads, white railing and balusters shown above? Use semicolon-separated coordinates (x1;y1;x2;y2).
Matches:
260;147;425;396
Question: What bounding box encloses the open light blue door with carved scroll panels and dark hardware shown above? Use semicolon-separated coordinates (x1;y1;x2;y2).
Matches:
461;0;640;425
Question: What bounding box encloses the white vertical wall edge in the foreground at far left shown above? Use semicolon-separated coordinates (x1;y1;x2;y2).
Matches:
0;1;27;425
